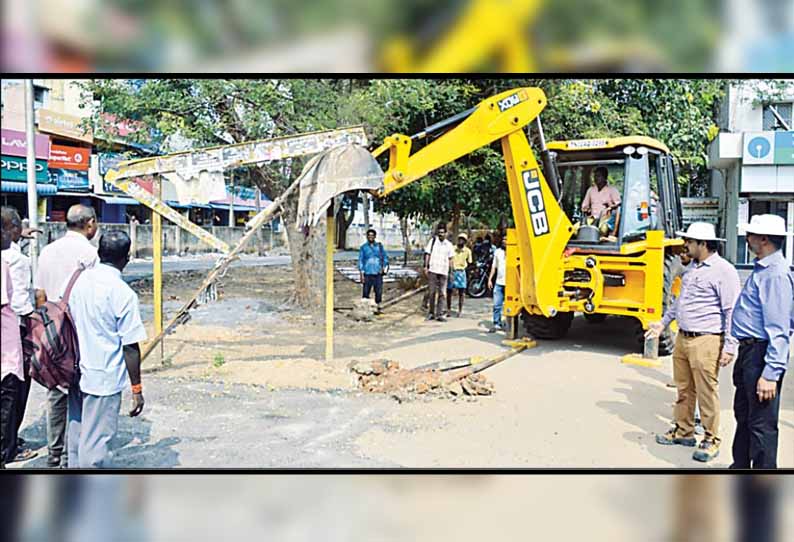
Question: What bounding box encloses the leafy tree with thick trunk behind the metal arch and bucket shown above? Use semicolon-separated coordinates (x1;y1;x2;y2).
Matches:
83;79;350;308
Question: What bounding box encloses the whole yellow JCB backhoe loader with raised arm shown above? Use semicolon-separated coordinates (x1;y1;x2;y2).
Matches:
372;88;683;355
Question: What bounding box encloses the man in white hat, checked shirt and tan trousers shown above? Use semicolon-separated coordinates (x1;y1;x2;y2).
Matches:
646;222;740;462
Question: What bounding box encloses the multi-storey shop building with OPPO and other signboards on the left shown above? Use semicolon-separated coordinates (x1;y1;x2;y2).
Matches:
0;79;278;229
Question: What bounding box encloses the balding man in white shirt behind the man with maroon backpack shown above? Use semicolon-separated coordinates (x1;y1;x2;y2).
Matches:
33;205;98;468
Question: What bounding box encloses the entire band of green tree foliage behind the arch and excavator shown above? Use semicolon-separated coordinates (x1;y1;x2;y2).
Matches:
80;78;736;226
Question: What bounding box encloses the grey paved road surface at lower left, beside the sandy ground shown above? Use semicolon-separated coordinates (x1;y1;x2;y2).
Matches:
11;374;401;468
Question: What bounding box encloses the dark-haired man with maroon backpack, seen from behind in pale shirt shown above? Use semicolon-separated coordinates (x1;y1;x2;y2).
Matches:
64;231;146;469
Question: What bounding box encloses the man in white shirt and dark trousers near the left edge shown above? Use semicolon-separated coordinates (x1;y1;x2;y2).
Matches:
2;207;37;461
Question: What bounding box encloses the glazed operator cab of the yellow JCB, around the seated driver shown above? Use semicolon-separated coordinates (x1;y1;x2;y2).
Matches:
548;136;682;251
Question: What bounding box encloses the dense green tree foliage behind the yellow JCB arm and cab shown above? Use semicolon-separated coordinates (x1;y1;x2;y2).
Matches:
348;79;726;228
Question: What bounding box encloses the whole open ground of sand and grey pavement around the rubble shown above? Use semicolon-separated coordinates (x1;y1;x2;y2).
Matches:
12;258;794;468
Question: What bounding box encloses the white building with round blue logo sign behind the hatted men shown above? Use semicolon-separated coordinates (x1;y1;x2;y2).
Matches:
708;82;794;265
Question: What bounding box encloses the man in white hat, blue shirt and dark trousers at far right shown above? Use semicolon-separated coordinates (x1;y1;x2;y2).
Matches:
731;215;794;469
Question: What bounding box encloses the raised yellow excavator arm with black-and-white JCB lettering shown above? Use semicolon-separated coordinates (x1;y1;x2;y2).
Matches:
372;88;573;316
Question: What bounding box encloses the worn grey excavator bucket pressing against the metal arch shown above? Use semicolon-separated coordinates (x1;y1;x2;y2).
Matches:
298;143;384;229
